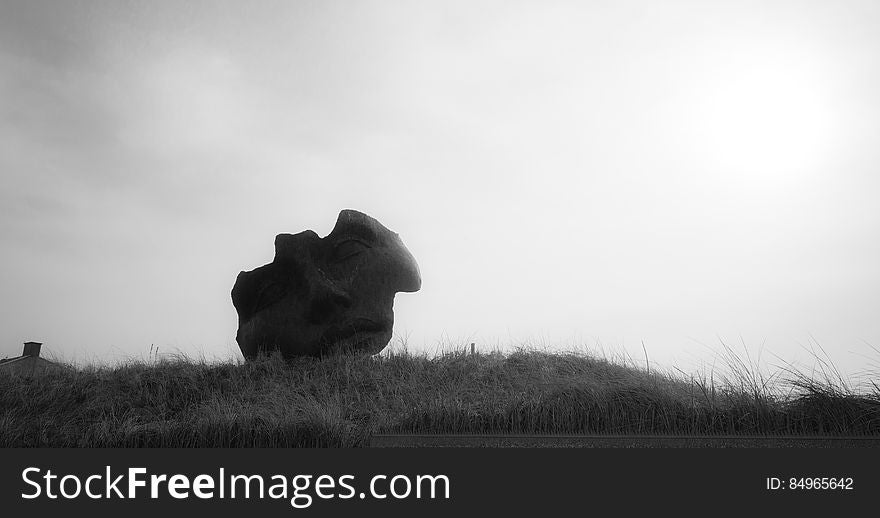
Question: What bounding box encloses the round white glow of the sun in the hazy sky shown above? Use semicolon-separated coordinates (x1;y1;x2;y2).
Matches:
697;50;834;187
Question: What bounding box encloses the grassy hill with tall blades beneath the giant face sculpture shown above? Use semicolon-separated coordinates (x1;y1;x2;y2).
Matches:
0;351;880;447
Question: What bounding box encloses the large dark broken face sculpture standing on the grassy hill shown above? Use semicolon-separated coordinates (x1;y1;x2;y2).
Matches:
232;210;422;359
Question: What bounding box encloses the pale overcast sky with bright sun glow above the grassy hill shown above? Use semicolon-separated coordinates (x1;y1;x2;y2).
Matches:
0;0;880;382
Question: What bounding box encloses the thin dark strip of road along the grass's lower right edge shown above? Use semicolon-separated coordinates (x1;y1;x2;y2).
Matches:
370;434;880;448
